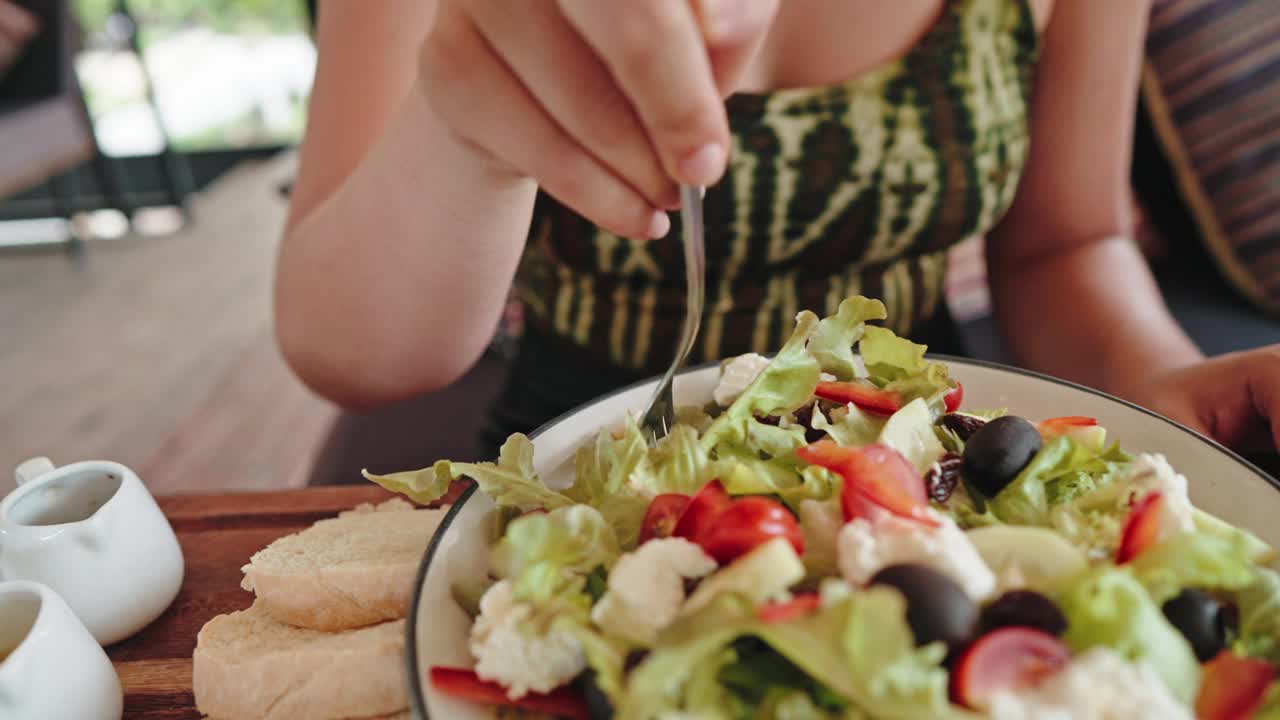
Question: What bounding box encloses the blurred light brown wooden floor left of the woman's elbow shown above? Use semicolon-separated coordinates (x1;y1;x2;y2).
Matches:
0;156;335;495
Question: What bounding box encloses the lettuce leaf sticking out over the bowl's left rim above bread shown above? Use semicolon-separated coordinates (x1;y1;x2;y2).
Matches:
362;433;573;511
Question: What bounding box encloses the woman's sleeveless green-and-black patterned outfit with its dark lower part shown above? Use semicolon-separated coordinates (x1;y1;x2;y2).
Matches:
492;0;1038;438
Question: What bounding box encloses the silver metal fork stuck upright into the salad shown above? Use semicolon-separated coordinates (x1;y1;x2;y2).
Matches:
640;184;707;446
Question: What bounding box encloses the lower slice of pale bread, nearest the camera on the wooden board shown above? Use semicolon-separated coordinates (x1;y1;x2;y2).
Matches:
192;602;408;720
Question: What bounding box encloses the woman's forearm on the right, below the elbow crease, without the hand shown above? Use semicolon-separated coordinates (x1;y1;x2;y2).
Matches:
989;238;1202;397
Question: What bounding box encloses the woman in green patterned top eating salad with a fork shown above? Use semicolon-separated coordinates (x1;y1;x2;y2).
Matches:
276;0;1280;466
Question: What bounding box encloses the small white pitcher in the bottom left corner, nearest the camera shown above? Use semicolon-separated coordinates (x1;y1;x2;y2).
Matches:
0;580;124;720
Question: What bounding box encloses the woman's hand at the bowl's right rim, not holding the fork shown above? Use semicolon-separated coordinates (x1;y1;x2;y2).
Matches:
1126;345;1280;452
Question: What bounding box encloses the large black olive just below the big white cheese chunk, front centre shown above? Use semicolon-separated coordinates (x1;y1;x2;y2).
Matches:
869;565;978;651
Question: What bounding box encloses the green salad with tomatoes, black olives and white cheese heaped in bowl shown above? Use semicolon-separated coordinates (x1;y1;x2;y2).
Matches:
366;297;1280;720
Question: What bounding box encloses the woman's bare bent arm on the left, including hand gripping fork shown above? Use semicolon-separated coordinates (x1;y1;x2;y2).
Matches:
276;0;777;405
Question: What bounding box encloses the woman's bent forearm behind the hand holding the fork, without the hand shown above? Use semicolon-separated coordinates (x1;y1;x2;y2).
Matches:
275;77;536;406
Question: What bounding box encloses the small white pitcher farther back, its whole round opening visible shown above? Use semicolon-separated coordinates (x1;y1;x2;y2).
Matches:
0;457;183;646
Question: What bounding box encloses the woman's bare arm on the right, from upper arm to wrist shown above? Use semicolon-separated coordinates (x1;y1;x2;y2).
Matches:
987;0;1202;396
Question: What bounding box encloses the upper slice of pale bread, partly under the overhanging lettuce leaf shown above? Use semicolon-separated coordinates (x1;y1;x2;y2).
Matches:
241;500;444;630
